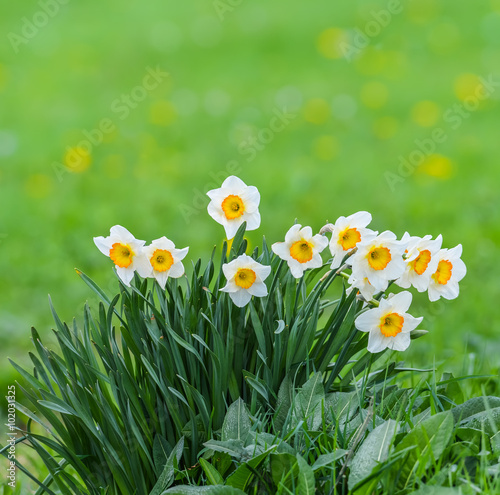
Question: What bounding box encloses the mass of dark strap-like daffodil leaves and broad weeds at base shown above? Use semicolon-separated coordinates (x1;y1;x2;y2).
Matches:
2;227;500;495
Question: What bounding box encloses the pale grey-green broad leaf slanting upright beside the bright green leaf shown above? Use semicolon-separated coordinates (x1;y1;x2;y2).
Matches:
348;419;397;490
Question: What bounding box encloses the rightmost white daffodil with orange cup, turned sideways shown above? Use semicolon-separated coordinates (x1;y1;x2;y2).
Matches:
429;244;467;301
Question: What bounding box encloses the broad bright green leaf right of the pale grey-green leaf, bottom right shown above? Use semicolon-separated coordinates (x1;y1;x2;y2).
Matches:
396;411;453;484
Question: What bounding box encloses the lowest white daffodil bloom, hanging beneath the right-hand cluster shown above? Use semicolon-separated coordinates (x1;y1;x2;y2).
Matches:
354;291;423;353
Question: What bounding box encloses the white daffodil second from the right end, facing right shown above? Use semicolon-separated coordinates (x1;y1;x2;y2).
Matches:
396;232;443;292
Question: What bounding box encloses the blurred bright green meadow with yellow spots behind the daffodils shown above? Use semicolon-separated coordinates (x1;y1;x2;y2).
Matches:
0;0;500;390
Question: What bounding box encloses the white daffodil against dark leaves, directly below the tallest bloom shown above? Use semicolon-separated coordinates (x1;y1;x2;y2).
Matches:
220;254;271;308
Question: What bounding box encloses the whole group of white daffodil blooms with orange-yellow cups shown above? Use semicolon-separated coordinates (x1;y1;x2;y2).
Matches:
94;176;467;353
